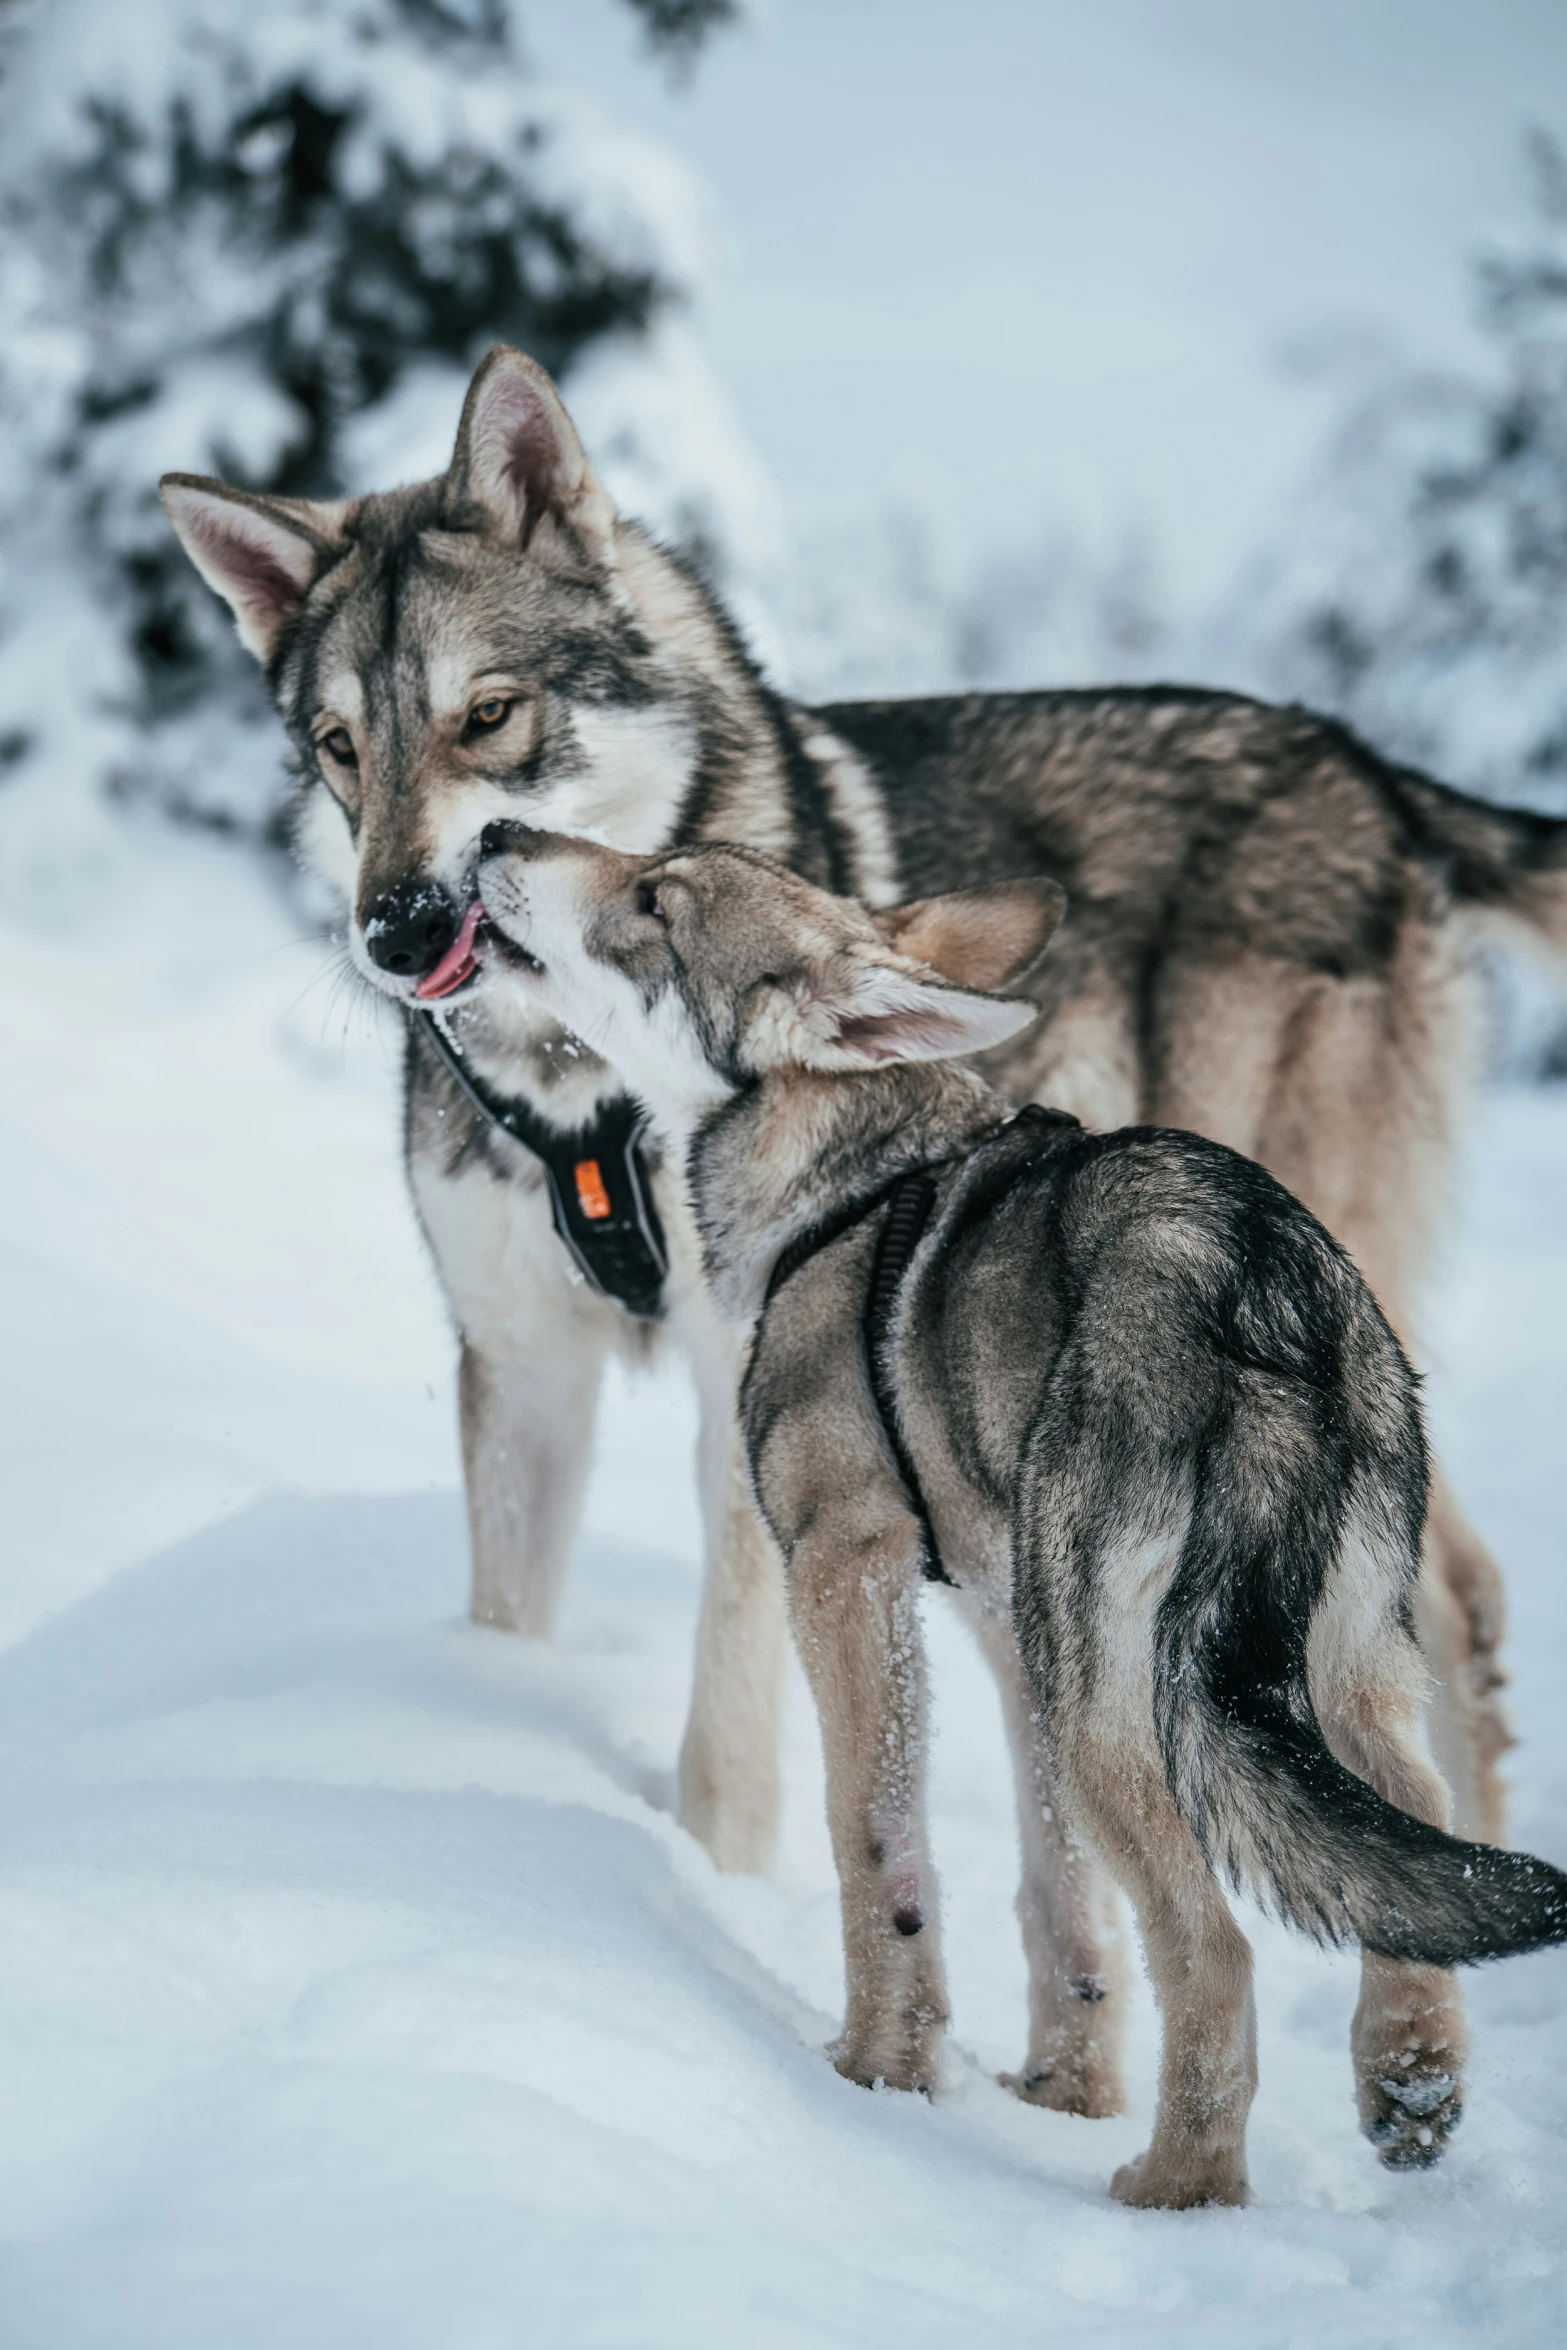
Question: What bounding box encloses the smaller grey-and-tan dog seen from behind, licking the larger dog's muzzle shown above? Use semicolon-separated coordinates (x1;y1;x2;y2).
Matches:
479;823;1567;2207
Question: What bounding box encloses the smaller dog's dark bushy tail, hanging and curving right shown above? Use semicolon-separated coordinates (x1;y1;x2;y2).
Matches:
1156;1469;1567;1967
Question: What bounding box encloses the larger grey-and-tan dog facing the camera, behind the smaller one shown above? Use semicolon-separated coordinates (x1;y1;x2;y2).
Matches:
164;336;1567;2152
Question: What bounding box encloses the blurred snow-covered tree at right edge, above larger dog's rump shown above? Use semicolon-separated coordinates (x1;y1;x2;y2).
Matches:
1219;134;1567;806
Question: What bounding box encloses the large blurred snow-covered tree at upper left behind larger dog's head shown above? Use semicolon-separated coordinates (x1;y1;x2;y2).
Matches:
0;0;742;874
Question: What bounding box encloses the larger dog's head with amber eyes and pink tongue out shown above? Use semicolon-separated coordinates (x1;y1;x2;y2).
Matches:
162;350;712;1001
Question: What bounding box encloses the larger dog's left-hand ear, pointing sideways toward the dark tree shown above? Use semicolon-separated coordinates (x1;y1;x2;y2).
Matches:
157;472;343;663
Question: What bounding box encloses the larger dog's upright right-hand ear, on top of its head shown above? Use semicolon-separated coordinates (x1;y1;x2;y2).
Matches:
446;343;616;562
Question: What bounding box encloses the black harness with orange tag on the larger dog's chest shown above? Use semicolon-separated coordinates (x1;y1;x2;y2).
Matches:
416;1013;670;1321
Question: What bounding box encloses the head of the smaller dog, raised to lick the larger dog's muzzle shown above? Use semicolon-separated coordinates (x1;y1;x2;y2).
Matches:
479;823;1064;1135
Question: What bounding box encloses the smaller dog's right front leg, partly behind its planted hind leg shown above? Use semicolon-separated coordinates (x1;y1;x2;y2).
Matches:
961;1586;1128;2115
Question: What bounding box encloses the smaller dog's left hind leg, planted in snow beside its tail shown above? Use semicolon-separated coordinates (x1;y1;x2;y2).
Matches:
1081;1746;1257;2211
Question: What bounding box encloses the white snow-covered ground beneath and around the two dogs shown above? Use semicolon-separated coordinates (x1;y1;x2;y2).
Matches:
0;837;1567;2350
